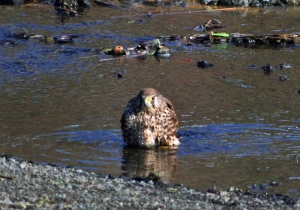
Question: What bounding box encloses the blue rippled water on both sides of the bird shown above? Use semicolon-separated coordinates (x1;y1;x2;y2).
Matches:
40;123;300;168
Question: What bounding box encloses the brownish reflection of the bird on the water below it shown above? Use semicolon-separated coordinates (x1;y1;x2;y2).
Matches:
122;147;178;182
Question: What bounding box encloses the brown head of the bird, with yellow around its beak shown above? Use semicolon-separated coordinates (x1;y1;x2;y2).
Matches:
139;88;160;114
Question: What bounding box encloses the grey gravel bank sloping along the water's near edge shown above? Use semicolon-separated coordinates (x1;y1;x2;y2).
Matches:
0;157;300;210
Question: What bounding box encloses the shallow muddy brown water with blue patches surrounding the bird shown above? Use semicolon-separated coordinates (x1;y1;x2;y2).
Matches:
0;3;300;197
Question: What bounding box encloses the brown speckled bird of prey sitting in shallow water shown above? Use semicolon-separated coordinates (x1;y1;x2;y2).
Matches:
120;88;180;148
